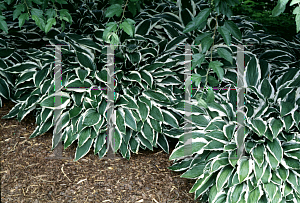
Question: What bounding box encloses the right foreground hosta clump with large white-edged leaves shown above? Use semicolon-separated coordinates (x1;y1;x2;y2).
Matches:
169;48;300;203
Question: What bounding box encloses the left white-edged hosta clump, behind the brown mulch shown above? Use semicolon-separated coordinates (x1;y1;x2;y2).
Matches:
1;2;202;160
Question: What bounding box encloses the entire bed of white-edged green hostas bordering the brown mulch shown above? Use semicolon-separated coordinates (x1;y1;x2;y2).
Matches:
0;0;300;203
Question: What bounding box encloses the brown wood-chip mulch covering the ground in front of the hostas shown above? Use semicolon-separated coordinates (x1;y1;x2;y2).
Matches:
0;100;204;203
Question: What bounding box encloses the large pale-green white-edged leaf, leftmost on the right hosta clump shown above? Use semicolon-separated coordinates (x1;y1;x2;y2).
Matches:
169;138;207;161
